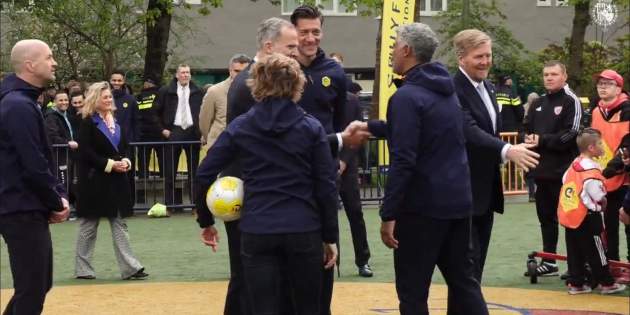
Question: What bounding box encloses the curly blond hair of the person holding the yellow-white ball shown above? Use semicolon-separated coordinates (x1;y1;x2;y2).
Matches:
247;53;306;102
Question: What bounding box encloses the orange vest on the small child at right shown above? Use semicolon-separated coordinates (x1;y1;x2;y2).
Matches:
558;157;604;229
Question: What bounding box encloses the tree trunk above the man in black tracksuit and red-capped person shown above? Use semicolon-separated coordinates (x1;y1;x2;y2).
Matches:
567;0;591;94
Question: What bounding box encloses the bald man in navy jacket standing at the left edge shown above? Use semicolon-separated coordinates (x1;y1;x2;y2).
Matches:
0;39;70;315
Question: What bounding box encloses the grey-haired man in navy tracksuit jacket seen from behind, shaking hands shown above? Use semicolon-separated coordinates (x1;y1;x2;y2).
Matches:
369;23;488;315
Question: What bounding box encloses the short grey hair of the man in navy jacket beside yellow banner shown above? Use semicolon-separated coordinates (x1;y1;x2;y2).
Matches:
396;23;440;63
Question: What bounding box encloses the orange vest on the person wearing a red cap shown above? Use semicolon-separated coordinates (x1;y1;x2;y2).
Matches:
591;107;630;191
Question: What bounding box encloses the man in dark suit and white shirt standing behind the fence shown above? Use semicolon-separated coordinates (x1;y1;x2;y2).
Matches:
156;64;205;210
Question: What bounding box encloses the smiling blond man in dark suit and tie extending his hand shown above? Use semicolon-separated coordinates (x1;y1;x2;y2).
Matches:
453;29;539;282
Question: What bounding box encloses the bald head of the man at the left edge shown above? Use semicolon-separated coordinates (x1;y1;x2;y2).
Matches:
11;39;57;87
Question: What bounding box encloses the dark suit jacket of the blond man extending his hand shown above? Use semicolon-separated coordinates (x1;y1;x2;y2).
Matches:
453;70;506;215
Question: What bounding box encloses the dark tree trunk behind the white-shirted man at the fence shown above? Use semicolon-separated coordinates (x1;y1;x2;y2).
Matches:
144;0;171;84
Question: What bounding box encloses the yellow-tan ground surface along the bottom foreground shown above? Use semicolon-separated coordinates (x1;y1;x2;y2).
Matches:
0;282;630;315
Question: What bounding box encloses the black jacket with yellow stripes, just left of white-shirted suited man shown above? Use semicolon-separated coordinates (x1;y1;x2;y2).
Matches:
136;87;163;141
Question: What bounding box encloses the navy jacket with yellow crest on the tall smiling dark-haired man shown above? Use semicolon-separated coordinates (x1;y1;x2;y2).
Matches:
298;48;350;134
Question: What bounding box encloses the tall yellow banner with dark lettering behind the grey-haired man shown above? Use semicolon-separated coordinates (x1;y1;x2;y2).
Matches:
378;0;415;165
